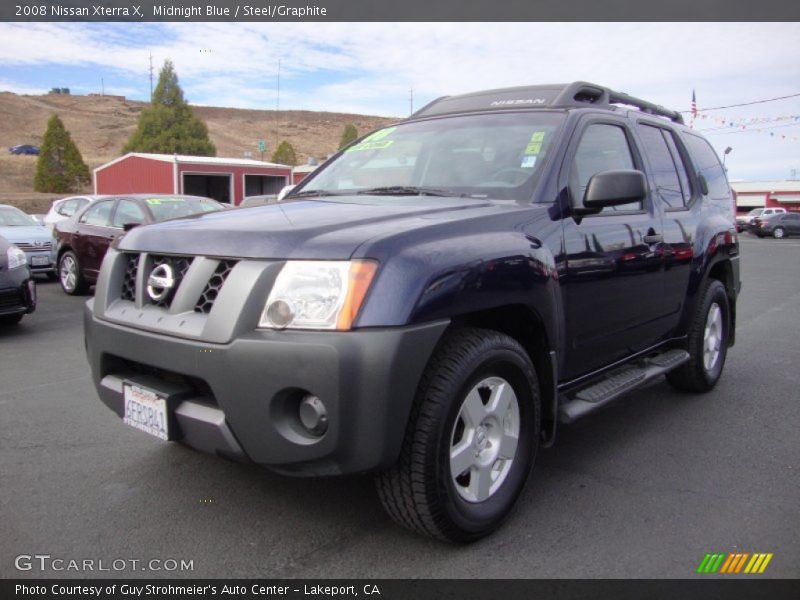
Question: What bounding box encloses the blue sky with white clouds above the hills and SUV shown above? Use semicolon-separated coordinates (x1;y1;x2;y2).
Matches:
0;23;800;180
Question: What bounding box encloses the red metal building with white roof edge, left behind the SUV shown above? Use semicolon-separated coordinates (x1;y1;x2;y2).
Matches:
94;152;292;205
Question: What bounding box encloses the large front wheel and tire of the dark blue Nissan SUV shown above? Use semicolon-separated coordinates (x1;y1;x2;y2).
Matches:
376;328;541;542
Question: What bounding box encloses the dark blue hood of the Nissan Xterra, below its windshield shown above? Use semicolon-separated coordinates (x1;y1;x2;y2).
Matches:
118;196;518;260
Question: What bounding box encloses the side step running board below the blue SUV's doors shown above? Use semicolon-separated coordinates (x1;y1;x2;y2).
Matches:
558;350;689;423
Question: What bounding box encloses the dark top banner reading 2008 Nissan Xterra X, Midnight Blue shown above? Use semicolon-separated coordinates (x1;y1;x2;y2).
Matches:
0;0;800;21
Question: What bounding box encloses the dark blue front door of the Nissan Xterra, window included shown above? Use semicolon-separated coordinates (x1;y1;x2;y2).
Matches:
562;120;664;379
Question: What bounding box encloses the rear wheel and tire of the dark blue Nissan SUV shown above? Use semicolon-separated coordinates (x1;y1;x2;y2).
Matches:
667;279;730;393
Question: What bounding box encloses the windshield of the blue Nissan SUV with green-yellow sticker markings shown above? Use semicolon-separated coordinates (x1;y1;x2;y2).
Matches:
296;112;564;202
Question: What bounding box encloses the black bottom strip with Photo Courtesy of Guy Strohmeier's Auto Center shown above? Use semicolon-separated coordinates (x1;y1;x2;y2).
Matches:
0;576;800;600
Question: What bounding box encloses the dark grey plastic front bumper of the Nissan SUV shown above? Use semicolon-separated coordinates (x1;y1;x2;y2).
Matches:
84;301;448;475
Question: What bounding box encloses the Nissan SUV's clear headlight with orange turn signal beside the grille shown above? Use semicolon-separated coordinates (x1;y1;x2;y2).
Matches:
258;260;378;331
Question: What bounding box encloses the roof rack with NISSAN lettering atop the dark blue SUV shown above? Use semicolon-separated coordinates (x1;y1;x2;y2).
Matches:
409;81;683;123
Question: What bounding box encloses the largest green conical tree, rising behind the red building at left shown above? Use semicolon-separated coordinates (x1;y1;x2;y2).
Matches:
122;60;217;156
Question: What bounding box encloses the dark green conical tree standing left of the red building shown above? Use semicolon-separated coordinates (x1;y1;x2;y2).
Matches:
33;115;91;194
